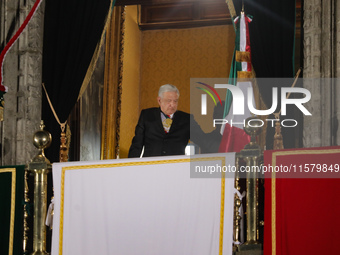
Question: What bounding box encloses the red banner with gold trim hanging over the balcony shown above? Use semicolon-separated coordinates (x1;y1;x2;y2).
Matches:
264;147;340;255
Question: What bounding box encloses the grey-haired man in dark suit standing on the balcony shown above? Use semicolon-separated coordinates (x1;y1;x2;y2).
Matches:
129;84;190;158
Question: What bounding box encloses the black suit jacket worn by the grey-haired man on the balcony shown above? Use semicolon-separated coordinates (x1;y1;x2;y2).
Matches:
129;108;190;158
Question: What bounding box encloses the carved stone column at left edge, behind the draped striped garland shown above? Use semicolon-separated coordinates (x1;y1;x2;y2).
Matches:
0;0;45;165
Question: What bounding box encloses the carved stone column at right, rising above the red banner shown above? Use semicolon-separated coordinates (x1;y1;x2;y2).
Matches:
303;0;340;147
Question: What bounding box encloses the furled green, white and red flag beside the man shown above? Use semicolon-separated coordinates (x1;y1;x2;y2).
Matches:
219;11;255;152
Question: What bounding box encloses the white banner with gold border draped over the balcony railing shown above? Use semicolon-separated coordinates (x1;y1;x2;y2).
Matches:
52;153;235;255
